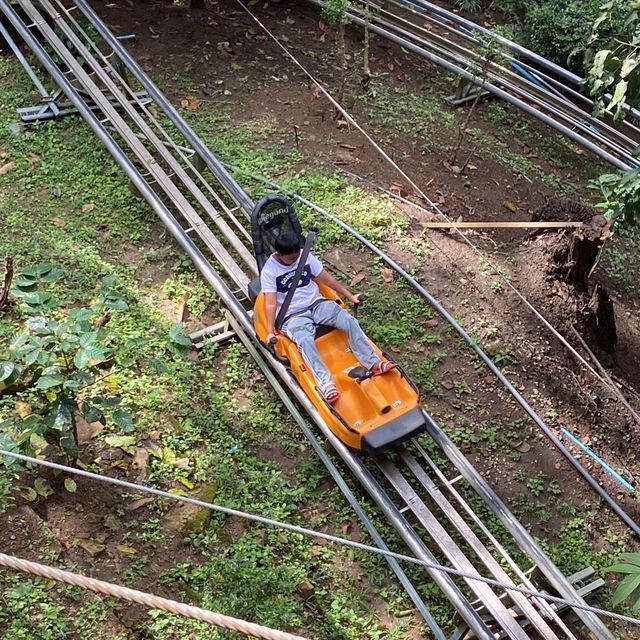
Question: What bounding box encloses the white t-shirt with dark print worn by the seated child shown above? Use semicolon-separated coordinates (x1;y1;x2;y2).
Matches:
260;253;323;317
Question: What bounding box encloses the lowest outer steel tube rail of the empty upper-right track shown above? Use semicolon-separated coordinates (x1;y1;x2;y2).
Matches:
318;0;633;170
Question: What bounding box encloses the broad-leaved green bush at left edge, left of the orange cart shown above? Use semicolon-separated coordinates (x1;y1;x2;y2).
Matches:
0;265;139;460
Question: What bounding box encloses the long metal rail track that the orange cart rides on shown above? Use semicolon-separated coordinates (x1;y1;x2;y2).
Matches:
0;0;613;640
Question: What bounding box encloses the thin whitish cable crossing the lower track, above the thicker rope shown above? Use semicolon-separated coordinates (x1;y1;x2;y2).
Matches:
0;449;640;626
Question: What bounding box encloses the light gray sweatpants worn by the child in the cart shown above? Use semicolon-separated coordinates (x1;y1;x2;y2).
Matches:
282;300;379;391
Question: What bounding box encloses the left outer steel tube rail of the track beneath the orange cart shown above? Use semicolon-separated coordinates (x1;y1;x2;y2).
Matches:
0;0;616;637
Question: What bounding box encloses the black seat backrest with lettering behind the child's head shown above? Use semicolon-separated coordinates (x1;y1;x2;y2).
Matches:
251;193;304;271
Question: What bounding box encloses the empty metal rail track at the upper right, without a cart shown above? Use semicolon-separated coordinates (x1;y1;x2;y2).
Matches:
311;0;640;170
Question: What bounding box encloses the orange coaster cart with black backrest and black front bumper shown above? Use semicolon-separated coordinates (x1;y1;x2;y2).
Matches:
249;195;425;454
